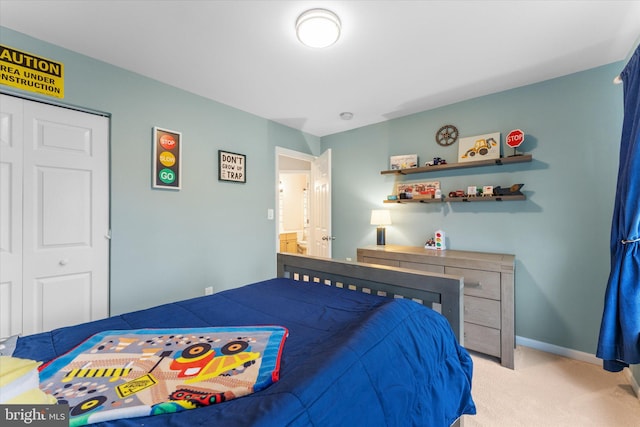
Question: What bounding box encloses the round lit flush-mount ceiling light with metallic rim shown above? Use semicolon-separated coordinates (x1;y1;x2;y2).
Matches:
296;9;342;48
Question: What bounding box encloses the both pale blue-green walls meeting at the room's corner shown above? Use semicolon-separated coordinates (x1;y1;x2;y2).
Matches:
0;28;623;362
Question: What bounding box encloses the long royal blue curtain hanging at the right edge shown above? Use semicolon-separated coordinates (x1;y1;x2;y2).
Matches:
596;42;640;372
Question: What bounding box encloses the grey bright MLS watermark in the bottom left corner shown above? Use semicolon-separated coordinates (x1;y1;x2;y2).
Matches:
0;405;69;427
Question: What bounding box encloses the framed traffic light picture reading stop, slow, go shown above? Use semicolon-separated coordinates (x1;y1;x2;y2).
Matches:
152;127;182;190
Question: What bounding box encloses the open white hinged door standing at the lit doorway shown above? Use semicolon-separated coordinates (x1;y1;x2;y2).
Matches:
310;149;334;258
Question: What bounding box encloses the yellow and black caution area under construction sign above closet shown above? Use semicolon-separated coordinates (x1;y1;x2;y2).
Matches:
0;44;64;98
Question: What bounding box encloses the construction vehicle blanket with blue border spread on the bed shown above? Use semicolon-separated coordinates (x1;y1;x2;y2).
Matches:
40;326;288;426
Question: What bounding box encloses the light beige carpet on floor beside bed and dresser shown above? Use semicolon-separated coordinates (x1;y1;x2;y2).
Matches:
463;346;640;427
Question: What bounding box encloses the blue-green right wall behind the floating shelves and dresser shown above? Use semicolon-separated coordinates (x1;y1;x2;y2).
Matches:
322;63;623;354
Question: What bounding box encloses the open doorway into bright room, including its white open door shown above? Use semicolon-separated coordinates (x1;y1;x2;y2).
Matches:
275;147;333;258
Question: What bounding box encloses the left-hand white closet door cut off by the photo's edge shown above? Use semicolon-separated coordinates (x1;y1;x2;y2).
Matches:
0;95;23;337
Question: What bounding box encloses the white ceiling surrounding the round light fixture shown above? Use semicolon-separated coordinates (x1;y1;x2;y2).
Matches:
0;0;640;136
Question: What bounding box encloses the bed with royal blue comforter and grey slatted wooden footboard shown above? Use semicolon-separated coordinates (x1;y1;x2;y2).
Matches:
5;254;475;427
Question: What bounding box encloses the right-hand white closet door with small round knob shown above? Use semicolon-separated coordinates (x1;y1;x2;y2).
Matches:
0;95;109;335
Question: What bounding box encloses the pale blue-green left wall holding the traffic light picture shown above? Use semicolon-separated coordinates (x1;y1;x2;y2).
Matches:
0;28;320;314
